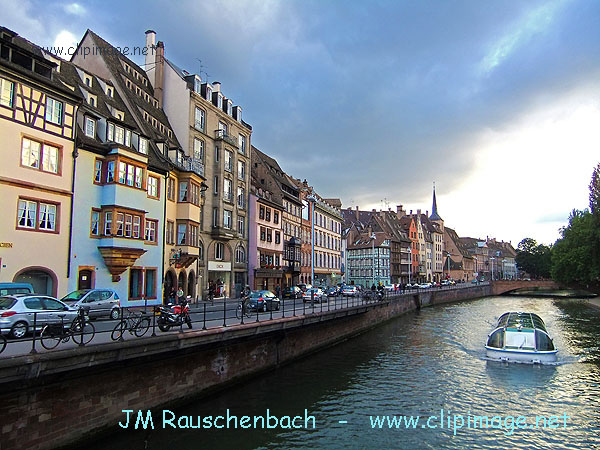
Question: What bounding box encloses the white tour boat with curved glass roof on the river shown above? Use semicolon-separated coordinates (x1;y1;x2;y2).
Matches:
485;312;558;364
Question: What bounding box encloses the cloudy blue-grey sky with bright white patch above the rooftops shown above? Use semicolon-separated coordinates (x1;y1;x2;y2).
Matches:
0;0;600;247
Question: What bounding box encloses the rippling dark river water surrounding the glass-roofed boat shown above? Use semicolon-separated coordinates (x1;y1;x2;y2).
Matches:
82;297;600;450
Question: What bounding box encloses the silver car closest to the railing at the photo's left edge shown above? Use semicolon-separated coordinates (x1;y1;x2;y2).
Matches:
0;294;78;338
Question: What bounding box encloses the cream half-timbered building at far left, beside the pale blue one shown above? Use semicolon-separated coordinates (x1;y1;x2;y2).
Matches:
0;27;81;296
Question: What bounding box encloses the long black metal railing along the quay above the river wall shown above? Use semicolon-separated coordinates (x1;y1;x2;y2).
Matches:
0;282;482;357
